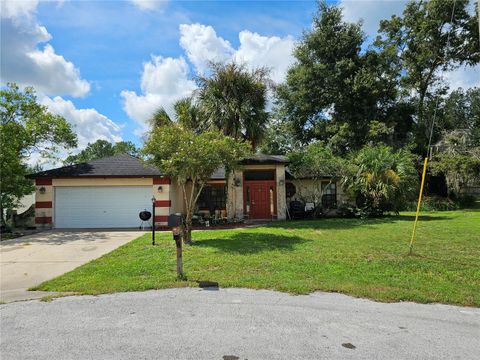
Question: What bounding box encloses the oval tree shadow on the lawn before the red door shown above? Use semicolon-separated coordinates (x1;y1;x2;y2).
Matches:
193;232;310;254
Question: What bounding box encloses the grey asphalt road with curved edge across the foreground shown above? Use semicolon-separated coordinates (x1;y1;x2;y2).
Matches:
0;289;480;360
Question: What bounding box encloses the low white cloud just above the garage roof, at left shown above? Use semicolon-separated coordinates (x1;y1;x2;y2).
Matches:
39;96;122;150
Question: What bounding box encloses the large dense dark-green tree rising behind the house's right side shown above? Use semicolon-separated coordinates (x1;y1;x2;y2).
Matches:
276;2;412;153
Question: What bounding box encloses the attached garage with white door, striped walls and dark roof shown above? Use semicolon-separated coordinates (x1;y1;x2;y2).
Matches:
28;154;171;229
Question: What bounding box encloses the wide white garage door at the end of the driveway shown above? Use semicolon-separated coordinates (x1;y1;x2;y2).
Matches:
54;186;152;229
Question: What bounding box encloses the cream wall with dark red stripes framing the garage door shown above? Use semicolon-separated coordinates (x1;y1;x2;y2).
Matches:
35;177;171;228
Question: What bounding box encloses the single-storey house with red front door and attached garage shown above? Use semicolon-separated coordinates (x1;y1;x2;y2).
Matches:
29;155;344;229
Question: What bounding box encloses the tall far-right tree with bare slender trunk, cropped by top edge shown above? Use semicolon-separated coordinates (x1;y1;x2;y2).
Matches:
375;0;480;151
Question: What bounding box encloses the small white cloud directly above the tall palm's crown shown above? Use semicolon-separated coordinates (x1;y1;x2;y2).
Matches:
180;24;234;73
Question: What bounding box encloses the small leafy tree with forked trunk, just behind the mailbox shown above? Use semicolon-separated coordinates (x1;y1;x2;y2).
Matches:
142;124;250;243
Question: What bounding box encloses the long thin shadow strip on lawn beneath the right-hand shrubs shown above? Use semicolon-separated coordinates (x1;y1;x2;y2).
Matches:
265;215;452;229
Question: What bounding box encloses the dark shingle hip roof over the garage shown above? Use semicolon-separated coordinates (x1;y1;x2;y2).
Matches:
28;154;161;179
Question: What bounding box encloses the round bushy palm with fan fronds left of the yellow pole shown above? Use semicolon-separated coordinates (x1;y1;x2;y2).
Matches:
344;145;418;216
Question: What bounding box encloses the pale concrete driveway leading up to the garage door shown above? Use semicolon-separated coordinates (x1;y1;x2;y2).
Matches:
0;230;144;302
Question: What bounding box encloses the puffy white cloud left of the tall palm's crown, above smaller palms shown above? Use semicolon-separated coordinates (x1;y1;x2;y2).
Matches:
121;56;196;129
